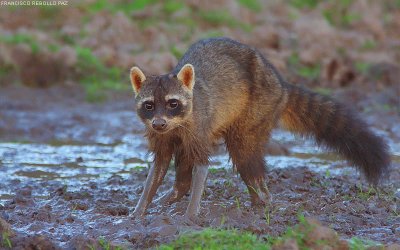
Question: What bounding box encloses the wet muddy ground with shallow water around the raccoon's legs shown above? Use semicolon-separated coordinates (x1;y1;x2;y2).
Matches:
0;86;400;249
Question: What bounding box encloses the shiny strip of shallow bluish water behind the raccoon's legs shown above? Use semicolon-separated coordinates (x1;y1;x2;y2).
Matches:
0;130;400;203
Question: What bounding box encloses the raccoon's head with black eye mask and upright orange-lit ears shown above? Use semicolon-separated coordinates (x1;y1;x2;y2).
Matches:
130;64;195;133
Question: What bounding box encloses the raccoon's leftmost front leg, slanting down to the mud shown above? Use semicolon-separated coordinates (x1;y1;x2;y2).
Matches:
133;152;172;217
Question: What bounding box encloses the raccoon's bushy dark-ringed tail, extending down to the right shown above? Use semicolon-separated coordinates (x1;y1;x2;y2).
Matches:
281;85;390;185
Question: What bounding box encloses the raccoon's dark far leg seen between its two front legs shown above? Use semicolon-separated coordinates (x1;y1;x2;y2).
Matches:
159;147;193;205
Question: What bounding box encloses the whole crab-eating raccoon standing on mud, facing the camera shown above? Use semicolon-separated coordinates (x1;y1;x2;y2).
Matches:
130;38;390;218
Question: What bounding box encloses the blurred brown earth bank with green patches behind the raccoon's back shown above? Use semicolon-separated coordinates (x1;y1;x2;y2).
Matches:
0;0;400;101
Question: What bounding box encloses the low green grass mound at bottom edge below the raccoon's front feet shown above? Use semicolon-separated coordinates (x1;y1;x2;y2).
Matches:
159;228;270;250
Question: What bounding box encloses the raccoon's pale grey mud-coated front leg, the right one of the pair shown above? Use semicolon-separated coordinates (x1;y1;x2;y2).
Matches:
185;166;208;219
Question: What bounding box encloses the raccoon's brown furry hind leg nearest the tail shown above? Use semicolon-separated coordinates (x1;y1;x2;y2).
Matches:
226;131;270;206
